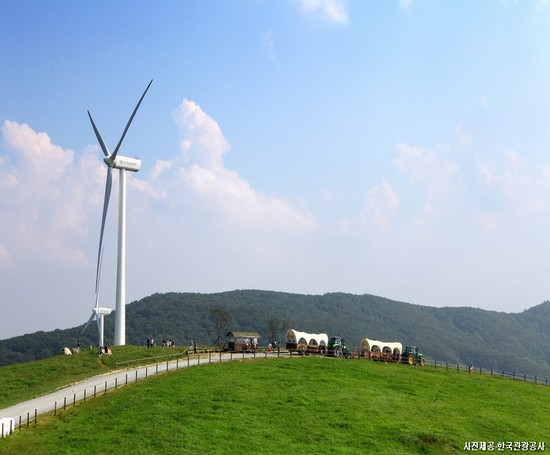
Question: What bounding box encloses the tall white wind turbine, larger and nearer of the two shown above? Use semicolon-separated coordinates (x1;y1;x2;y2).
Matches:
84;80;153;346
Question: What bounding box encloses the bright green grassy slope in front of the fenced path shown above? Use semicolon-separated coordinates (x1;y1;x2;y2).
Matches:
0;358;550;454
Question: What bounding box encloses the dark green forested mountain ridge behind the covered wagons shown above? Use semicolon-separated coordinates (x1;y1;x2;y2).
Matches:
0;290;550;378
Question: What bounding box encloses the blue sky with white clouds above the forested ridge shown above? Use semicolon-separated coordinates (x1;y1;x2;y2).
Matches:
0;0;550;338
